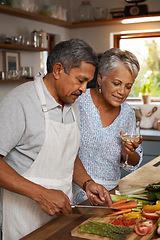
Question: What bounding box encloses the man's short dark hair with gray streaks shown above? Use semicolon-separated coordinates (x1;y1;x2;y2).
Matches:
47;38;97;74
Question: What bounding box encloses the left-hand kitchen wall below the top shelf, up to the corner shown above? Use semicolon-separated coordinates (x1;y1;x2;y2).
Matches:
0;13;70;99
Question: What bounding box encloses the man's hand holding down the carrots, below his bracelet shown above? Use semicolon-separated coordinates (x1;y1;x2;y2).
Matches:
86;181;112;207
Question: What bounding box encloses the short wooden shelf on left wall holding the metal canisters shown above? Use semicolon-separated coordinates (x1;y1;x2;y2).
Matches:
0;43;48;52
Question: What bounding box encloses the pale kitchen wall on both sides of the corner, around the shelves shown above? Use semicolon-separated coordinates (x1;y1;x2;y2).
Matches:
0;0;160;99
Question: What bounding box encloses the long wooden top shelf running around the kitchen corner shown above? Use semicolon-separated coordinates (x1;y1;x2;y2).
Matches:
0;5;160;28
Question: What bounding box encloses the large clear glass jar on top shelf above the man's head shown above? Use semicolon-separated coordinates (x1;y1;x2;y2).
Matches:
79;1;93;21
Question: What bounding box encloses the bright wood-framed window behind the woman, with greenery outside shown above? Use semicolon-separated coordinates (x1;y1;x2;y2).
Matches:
114;32;160;101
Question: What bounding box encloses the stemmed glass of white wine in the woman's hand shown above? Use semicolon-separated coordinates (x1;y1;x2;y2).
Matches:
120;121;140;169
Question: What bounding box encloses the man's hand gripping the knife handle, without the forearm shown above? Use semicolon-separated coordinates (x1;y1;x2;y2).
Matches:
37;188;72;216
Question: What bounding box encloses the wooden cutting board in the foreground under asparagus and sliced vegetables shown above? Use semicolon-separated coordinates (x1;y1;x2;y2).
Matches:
71;215;157;240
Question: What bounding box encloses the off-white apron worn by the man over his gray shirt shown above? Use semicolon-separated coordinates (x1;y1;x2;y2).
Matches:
2;78;80;240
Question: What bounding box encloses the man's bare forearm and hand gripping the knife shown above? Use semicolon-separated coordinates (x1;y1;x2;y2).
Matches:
0;156;72;216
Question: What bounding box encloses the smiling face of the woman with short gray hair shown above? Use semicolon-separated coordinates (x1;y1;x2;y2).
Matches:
98;66;134;107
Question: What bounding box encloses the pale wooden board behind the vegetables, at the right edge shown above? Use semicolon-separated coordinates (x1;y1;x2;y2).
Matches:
118;156;160;192
